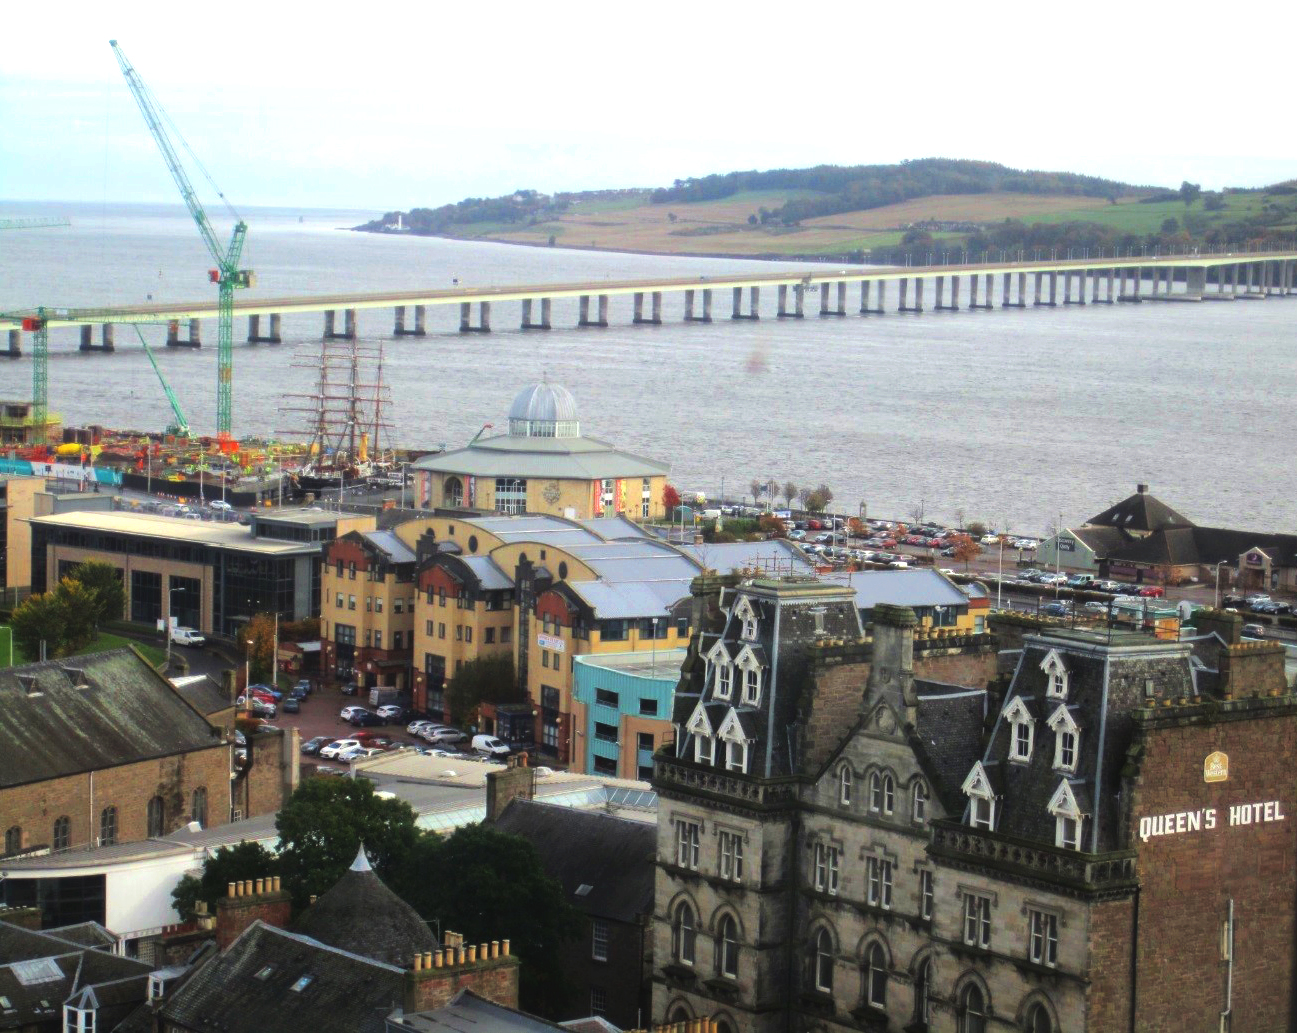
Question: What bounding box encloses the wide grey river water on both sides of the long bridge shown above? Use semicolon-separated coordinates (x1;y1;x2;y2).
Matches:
0;202;1297;533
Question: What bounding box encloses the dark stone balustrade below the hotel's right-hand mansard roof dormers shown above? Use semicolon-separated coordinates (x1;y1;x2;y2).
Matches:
930;820;1139;894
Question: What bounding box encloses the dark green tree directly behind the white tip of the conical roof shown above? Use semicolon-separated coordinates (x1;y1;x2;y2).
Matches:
275;779;419;907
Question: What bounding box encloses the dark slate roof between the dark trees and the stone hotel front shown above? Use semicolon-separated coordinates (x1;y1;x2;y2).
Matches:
495;799;658;923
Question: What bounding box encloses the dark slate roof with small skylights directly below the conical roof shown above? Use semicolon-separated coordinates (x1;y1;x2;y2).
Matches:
161;919;405;1033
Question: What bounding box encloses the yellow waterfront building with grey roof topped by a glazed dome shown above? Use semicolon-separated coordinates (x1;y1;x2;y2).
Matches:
412;380;669;520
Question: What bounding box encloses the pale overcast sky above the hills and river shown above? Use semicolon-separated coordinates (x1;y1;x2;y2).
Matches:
0;0;1297;210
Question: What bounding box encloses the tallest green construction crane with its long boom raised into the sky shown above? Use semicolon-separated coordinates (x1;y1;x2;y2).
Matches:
109;39;256;441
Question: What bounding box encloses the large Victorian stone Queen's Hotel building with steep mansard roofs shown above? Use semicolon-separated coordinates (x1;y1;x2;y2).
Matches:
654;581;1297;1033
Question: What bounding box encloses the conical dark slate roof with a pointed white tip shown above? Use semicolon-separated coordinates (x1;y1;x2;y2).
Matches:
293;845;437;968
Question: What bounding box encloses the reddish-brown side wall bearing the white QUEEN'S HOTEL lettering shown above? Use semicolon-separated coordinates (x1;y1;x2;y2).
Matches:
1127;697;1297;1033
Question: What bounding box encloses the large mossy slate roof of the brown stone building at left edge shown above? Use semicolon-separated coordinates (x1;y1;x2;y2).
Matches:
0;649;220;786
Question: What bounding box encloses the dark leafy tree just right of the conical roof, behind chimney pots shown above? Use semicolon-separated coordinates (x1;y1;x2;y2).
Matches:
406;825;581;1015
